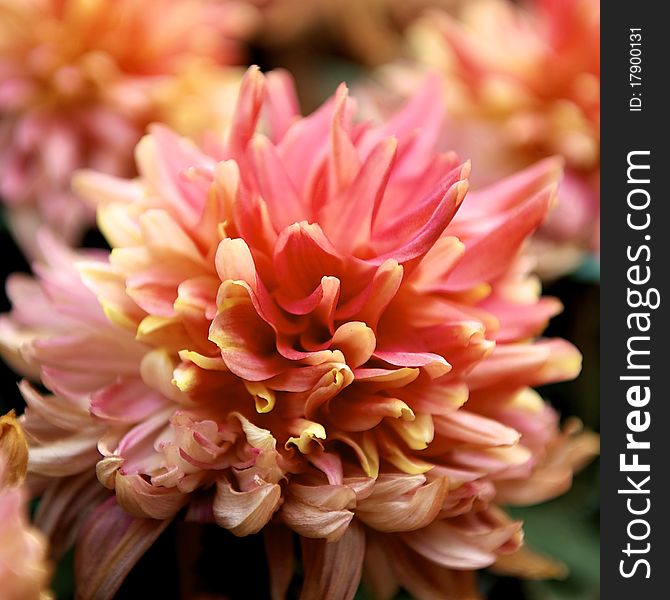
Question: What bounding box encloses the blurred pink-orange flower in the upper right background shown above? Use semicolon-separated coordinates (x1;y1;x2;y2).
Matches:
411;0;600;276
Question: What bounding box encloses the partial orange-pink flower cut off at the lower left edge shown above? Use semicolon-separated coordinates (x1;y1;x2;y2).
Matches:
0;413;52;600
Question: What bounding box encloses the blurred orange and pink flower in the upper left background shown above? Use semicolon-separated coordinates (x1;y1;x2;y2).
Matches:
0;0;251;254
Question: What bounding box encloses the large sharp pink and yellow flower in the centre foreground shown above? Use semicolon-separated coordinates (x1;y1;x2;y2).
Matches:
0;68;594;599
